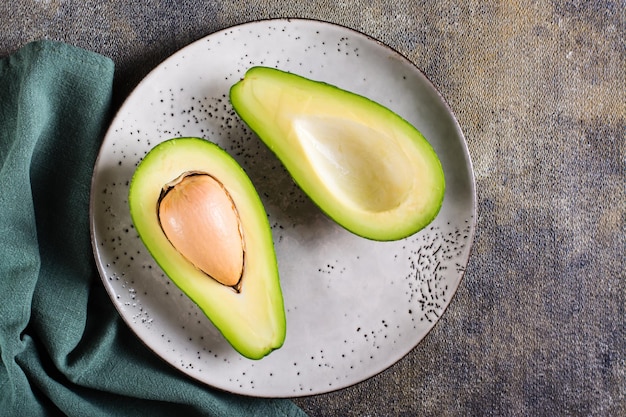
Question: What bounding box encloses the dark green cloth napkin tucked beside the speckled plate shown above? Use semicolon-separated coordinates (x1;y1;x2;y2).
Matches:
0;41;304;417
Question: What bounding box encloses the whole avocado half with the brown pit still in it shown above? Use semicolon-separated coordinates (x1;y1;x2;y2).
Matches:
129;138;286;359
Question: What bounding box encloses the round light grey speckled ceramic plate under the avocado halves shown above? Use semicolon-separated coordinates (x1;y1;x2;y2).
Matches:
91;19;475;397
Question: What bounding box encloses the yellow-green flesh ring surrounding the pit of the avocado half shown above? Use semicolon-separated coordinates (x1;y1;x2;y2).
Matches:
129;138;286;359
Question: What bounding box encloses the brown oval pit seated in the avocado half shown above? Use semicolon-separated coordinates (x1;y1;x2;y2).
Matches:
157;172;245;291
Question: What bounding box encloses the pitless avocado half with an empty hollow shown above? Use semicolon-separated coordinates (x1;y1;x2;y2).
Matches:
230;67;445;241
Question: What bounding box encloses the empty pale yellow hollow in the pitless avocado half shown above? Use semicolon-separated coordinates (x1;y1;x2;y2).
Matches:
293;116;414;213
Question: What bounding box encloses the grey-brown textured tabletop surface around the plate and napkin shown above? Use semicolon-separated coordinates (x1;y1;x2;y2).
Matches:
0;0;626;416
